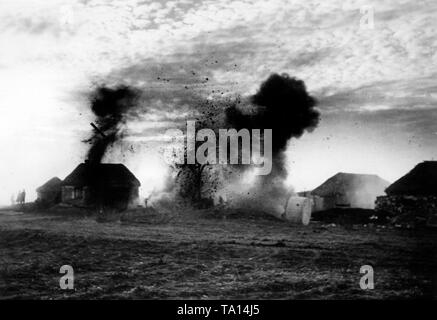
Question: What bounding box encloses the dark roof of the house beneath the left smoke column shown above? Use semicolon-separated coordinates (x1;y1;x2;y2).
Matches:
62;162;141;187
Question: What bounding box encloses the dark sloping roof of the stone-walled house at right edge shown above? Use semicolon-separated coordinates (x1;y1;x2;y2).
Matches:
385;161;437;195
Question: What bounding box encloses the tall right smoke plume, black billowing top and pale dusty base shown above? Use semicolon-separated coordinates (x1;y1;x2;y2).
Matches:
221;74;320;215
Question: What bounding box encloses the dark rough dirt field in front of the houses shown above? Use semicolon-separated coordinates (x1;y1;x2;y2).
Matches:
0;211;437;299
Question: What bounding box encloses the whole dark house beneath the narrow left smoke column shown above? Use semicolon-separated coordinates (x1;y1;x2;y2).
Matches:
61;161;140;209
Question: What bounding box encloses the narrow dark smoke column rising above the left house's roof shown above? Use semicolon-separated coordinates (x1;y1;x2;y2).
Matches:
86;86;140;163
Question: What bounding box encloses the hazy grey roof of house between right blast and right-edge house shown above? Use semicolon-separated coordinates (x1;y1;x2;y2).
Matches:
311;172;390;197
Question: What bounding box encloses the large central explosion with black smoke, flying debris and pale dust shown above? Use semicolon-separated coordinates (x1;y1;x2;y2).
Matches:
165;74;319;215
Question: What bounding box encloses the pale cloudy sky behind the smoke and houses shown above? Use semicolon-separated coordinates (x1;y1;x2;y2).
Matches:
0;0;437;203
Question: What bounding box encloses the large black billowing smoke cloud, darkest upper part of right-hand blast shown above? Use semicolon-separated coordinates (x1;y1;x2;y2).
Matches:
226;74;320;175
